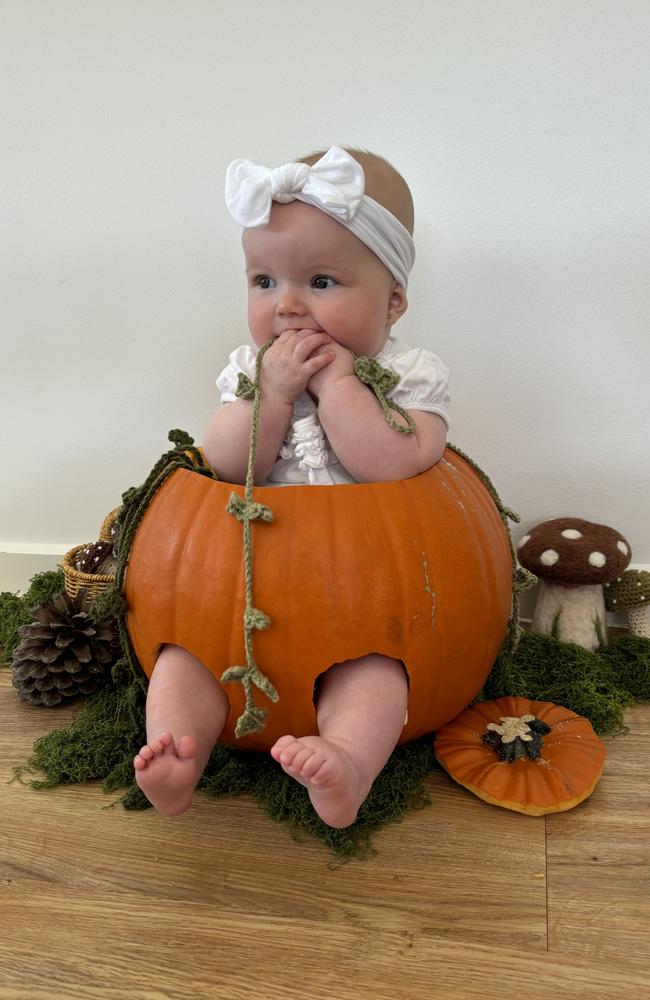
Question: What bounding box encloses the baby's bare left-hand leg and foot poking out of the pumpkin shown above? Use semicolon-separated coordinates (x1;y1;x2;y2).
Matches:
133;646;230;816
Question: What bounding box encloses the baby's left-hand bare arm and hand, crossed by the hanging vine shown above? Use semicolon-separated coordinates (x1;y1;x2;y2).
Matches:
203;330;333;483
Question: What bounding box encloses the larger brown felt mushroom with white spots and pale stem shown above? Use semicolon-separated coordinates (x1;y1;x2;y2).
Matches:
517;517;632;651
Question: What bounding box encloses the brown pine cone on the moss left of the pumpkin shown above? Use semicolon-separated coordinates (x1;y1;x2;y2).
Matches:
11;590;119;708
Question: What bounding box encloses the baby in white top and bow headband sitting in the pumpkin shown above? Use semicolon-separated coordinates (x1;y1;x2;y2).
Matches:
134;146;449;827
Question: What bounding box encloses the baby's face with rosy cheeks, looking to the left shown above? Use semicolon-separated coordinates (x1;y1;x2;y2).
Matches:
242;201;403;357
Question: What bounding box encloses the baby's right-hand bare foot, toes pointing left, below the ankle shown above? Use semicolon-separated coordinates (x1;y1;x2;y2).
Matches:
271;736;370;828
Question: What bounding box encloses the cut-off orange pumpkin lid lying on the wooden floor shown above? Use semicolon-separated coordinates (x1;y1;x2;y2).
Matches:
434;697;606;816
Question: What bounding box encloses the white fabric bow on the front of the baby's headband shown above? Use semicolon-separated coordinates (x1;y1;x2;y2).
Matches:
226;146;365;229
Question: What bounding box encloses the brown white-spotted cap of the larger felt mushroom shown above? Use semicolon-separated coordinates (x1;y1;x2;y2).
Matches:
517;517;632;586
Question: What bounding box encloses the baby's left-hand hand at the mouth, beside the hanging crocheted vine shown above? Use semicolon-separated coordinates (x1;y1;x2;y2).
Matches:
262;330;336;403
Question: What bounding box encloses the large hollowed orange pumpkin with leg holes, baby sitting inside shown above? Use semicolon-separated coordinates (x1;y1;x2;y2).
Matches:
125;450;513;750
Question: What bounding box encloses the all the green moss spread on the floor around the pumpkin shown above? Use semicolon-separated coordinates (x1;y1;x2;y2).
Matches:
8;573;650;864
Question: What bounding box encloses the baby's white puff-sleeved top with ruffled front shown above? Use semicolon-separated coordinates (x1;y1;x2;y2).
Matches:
217;337;449;486
